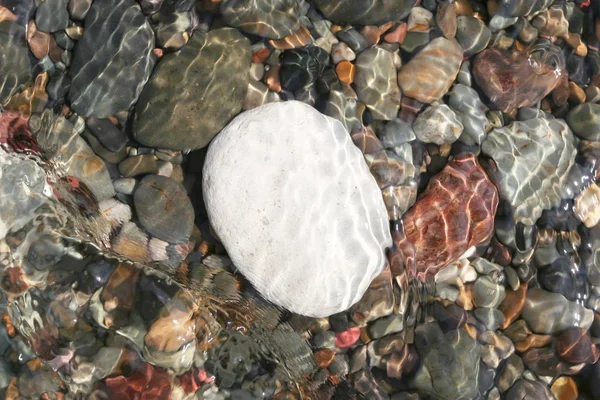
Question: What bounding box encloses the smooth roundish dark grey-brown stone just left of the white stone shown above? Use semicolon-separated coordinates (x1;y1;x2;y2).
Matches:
133;175;194;243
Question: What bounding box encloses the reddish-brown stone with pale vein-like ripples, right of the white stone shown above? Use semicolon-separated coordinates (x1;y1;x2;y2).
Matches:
398;153;498;280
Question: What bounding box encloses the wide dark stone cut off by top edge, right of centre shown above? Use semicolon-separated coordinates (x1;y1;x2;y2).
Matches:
315;0;416;25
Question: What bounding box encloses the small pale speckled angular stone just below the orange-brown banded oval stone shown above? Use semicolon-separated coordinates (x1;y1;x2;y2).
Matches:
413;104;463;145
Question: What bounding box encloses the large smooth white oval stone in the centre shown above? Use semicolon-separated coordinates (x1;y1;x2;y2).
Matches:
203;101;392;317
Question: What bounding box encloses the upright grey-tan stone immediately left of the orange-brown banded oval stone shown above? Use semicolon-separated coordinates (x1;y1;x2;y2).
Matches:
354;47;400;120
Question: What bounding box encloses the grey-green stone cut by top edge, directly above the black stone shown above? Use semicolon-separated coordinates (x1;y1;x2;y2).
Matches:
220;0;300;39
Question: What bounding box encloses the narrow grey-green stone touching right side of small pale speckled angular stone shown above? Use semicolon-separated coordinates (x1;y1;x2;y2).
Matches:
448;83;490;145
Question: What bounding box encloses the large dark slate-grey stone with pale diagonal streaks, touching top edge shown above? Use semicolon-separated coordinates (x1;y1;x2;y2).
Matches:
69;0;154;118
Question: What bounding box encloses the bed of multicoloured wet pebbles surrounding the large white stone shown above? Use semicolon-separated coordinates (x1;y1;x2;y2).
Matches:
0;0;600;400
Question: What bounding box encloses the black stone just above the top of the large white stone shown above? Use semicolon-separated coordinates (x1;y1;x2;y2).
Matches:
279;45;329;92
